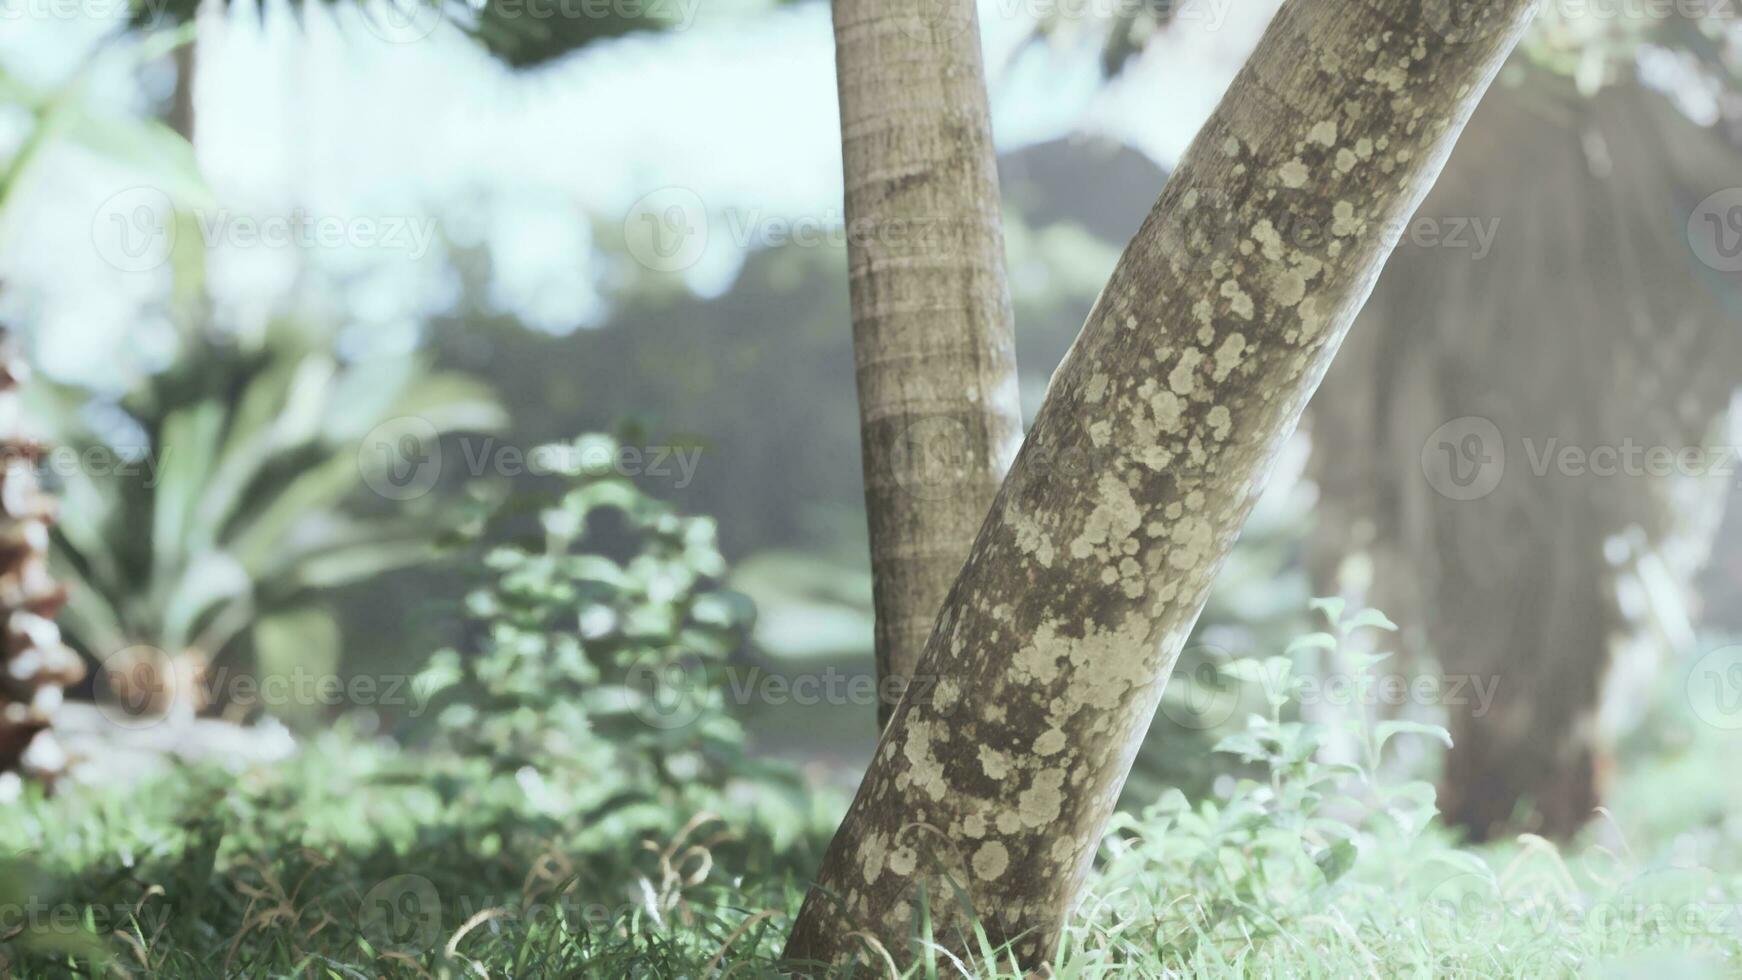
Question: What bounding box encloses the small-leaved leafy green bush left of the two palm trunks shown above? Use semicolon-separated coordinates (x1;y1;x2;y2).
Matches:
416;435;797;834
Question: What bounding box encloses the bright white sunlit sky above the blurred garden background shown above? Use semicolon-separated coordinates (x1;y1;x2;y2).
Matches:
0;0;1272;391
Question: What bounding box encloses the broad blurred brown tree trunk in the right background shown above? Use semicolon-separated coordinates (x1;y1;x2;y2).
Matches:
1308;78;1742;839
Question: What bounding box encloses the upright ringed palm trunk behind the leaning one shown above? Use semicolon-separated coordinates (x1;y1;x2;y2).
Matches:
834;0;1023;724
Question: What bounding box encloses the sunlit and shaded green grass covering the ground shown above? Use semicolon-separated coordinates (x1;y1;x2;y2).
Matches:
10;626;1742;978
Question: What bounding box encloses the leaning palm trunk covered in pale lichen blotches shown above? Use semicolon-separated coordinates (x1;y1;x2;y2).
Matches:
787;0;1529;968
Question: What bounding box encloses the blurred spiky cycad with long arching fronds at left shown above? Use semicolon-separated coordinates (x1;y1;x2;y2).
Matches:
28;326;503;715
